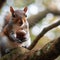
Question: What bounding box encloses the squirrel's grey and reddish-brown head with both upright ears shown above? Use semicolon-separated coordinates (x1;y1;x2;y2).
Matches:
10;6;27;26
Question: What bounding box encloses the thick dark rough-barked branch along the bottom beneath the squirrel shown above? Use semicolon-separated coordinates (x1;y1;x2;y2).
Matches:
0;37;60;60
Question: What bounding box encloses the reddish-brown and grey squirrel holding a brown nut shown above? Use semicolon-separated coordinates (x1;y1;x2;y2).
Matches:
0;7;31;55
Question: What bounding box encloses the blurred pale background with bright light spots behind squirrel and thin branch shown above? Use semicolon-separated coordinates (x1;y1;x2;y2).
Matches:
0;0;60;60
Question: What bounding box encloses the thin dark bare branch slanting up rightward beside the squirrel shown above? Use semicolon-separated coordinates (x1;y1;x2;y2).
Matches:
28;20;60;50
